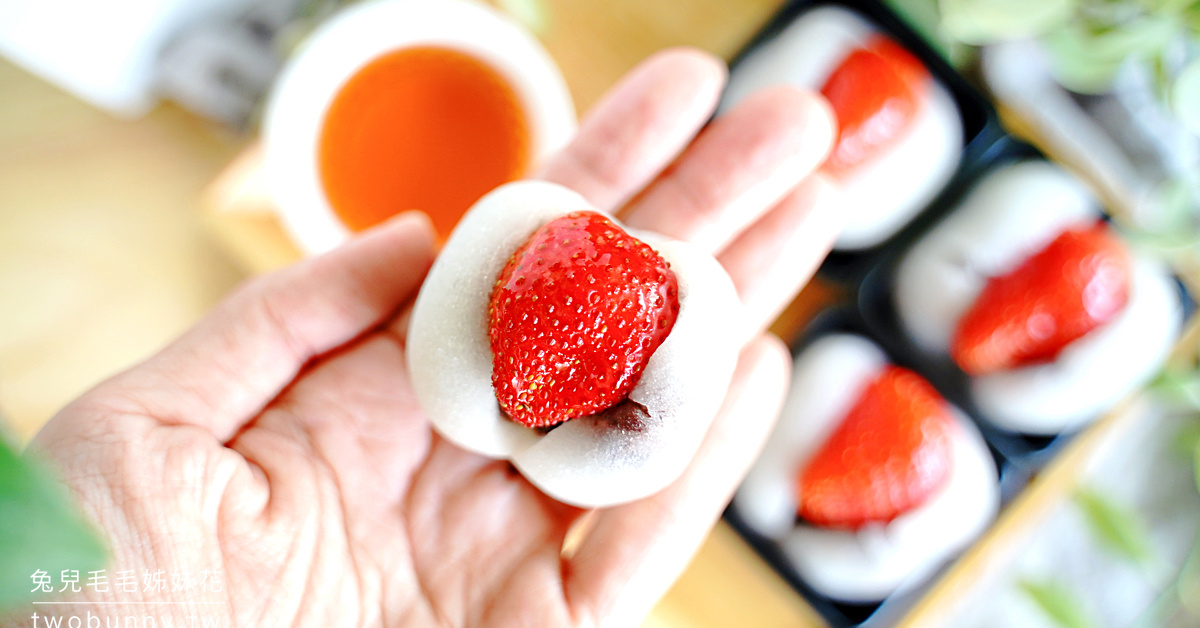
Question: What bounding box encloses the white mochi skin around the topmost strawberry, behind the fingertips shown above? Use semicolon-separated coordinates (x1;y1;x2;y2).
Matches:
721;7;962;250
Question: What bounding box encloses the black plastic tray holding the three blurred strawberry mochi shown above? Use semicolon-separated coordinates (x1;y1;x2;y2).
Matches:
725;0;1196;628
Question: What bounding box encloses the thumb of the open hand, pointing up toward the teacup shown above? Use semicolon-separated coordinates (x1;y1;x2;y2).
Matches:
95;213;433;441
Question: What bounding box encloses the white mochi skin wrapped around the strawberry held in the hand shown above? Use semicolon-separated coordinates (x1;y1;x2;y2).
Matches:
408;181;743;508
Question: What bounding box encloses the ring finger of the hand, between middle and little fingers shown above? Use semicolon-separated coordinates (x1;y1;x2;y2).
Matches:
718;174;844;336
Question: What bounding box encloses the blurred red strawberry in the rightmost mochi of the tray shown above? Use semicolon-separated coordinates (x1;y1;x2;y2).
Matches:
950;223;1129;375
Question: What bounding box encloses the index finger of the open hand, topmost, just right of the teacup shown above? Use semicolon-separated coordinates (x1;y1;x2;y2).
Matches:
538;48;725;210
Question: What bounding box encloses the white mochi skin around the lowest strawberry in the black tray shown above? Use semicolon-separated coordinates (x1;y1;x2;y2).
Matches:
734;334;1000;602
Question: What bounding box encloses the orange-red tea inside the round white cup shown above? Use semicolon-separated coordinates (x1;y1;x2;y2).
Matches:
318;47;530;239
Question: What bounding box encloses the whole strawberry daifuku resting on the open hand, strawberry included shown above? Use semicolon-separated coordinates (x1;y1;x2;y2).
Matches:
407;181;742;507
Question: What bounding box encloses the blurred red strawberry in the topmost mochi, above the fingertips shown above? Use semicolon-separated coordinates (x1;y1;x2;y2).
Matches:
821;35;929;173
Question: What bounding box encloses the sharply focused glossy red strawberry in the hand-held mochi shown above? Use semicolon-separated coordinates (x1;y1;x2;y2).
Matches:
488;211;679;427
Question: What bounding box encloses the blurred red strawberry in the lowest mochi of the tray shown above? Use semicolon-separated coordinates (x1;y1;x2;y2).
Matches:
797;366;953;528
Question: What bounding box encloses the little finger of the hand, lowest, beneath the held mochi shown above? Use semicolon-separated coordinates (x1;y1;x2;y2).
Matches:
564;336;790;626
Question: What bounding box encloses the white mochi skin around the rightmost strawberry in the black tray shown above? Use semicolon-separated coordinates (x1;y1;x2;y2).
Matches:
895;161;1182;435
